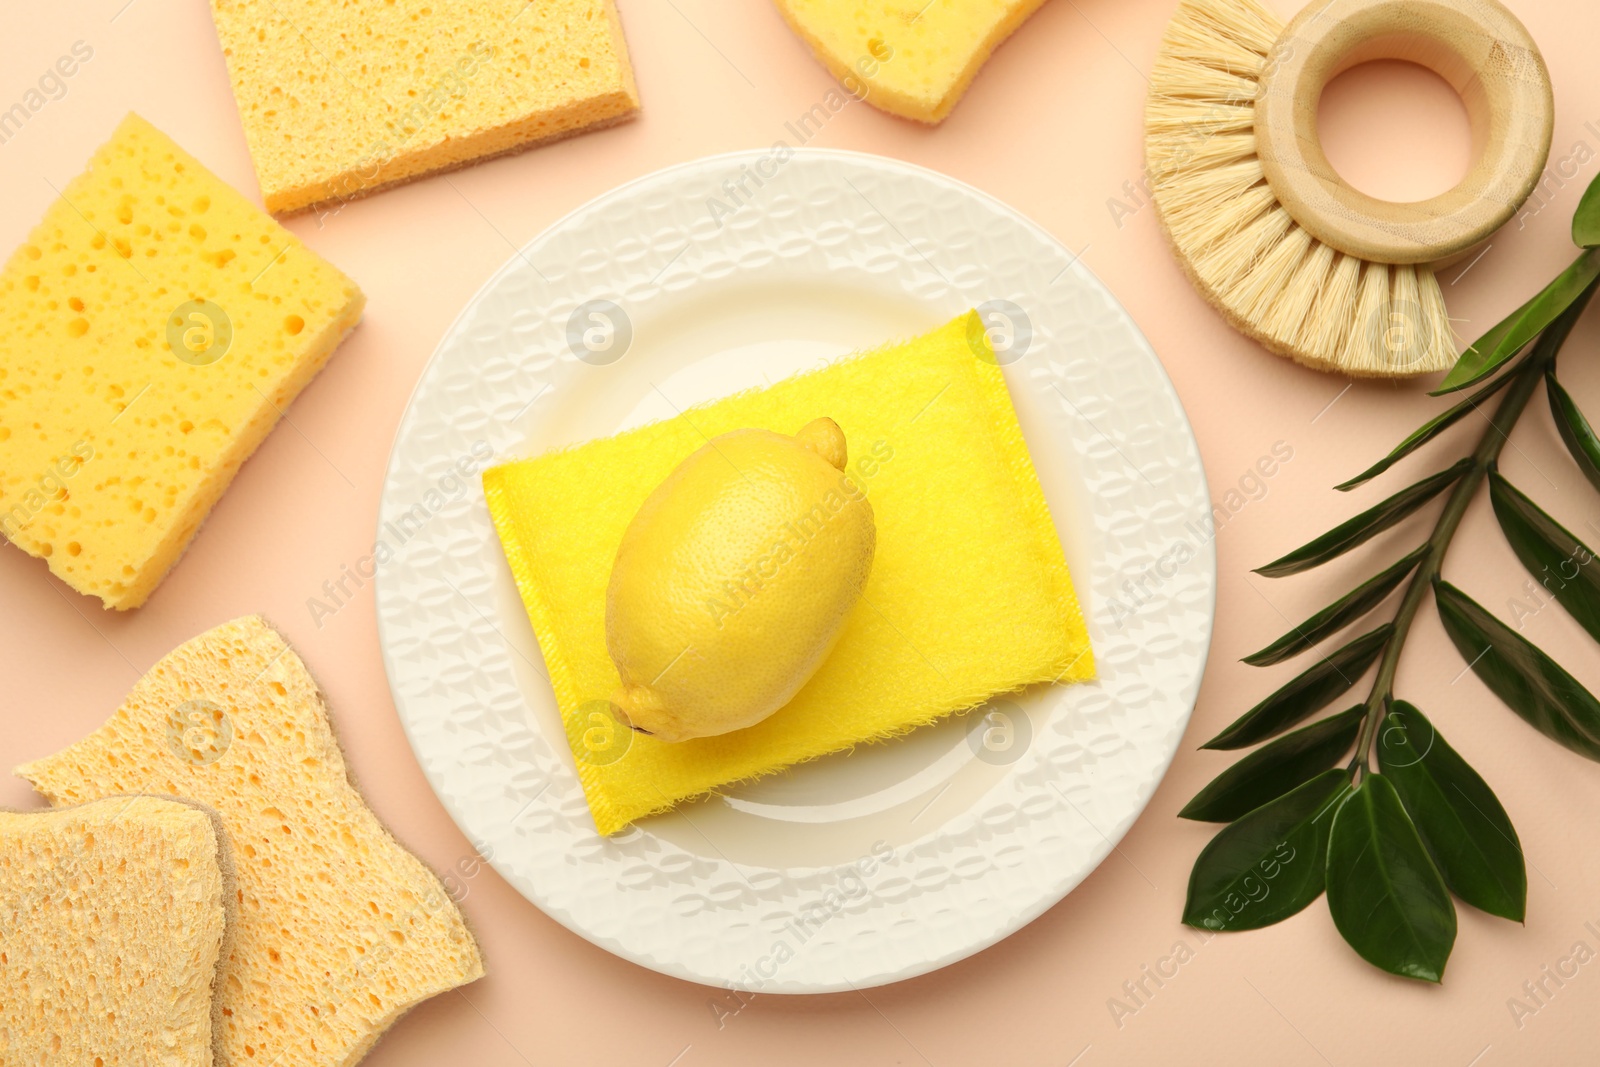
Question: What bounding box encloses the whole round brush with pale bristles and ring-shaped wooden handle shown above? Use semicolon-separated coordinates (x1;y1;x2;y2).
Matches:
1146;0;1554;378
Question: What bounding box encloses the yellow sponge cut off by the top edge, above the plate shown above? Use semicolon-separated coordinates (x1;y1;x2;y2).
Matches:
776;0;1045;123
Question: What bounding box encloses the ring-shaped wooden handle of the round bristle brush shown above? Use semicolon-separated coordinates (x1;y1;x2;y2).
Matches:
1256;0;1555;264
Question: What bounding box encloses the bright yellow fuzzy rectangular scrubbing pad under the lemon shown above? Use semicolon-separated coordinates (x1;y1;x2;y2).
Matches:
483;312;1094;833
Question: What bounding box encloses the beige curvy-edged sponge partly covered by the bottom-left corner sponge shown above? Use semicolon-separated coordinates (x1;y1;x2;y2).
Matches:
16;617;483;1067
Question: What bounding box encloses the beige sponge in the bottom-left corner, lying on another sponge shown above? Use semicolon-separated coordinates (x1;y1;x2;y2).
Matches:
0;797;227;1067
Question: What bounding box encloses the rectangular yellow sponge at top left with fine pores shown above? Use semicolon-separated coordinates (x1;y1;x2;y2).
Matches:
211;0;638;213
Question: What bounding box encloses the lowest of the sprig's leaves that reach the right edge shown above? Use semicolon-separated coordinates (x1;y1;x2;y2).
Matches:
1434;581;1600;760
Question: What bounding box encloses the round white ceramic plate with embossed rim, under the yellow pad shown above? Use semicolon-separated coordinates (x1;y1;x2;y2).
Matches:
378;150;1216;993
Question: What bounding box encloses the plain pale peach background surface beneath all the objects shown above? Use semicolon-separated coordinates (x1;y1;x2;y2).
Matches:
0;0;1600;1067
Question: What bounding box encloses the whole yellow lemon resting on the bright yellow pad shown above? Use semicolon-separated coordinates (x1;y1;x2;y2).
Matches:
606;419;877;741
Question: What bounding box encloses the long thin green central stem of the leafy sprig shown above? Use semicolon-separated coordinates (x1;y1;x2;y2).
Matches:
1350;290;1594;776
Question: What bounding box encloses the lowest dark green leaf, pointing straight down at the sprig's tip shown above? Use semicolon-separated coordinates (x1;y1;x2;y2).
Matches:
1326;774;1456;982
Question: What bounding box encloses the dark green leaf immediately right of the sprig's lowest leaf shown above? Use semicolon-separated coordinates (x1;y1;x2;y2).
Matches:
1378;701;1528;923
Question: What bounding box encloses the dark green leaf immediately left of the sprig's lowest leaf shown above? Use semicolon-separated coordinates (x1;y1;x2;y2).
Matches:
1184;769;1350;929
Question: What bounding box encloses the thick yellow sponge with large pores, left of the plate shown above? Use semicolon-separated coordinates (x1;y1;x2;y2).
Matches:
0;115;365;609
